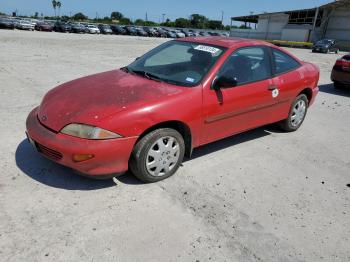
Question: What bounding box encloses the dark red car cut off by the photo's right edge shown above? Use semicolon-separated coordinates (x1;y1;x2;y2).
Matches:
331;53;350;89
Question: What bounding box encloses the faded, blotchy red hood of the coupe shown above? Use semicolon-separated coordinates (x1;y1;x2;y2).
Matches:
38;70;188;132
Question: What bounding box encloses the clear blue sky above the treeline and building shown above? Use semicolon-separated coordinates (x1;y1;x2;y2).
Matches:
0;0;331;24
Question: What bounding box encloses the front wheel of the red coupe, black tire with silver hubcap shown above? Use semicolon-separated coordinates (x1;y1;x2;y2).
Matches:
129;128;185;183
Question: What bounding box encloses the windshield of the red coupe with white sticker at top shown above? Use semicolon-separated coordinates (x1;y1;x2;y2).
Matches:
125;41;226;86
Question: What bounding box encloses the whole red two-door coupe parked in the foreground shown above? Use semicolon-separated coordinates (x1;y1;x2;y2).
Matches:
26;37;319;182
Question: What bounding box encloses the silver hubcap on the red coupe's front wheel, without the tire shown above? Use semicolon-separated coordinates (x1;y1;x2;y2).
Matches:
146;136;180;176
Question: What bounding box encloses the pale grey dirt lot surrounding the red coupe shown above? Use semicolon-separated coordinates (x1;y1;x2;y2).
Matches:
0;30;350;262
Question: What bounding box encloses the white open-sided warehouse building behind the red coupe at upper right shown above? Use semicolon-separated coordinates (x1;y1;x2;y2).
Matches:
231;0;350;50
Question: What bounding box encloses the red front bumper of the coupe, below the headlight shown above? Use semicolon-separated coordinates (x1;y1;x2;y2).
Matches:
26;108;137;177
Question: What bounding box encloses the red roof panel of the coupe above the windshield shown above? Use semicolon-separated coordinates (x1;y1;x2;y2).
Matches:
178;36;273;48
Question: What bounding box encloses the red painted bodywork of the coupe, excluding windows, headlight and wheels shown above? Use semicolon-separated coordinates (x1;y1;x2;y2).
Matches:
27;37;319;175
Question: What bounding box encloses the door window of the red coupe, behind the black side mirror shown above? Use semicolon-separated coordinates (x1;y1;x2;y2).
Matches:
219;47;271;85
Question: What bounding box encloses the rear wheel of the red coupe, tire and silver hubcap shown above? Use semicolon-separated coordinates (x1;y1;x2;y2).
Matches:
279;94;309;132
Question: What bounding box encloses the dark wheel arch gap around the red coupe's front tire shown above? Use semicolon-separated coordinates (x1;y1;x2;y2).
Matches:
136;120;193;157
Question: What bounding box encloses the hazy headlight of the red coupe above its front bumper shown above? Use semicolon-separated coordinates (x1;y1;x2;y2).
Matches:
61;124;122;140
